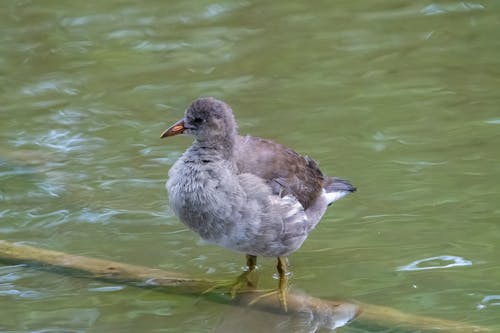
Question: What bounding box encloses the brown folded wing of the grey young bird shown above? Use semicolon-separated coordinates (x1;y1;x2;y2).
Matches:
235;136;324;209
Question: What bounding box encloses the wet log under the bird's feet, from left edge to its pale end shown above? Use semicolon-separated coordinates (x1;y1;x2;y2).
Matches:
0;240;359;329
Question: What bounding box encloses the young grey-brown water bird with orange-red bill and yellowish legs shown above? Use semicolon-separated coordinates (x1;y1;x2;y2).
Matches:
160;97;356;311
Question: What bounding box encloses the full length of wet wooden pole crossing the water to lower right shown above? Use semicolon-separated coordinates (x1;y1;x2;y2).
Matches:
0;240;489;333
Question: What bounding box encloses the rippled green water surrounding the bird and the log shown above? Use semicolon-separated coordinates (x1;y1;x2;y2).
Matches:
0;0;500;332
